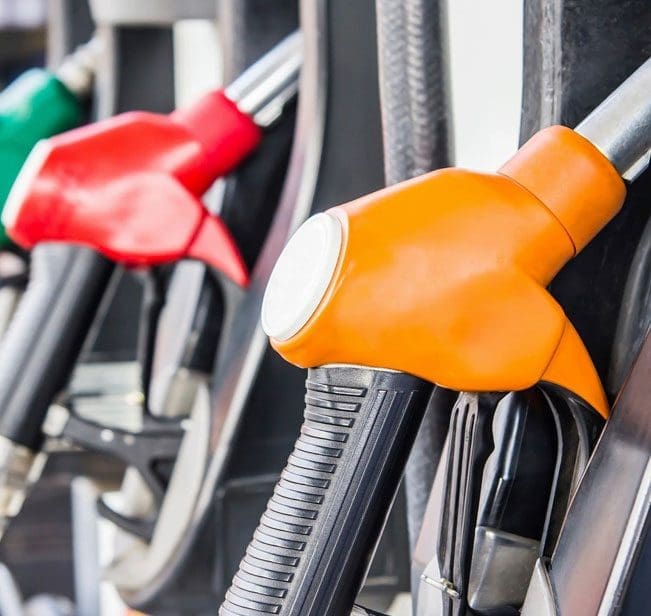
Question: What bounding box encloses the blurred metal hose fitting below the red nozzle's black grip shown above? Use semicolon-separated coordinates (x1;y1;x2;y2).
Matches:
0;436;45;537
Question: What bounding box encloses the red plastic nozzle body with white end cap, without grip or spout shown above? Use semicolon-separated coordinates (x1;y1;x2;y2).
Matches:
3;91;261;285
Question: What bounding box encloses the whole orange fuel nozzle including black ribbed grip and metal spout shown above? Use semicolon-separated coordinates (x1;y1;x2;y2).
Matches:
220;62;651;616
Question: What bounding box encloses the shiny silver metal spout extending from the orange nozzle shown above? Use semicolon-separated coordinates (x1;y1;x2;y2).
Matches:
574;58;651;180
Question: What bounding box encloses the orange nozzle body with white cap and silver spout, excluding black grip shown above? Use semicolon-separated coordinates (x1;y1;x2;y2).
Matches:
262;59;651;416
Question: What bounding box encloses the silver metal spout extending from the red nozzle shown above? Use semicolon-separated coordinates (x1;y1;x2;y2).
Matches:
225;32;303;128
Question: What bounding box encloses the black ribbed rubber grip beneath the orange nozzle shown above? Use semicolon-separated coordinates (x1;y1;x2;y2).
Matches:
219;366;432;616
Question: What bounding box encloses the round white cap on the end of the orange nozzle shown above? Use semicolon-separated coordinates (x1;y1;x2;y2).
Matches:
262;214;343;340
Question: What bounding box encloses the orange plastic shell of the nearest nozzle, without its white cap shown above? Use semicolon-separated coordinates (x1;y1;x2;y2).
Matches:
272;127;625;416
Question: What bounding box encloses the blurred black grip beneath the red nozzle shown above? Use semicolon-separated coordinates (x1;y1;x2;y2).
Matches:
0;244;114;449
